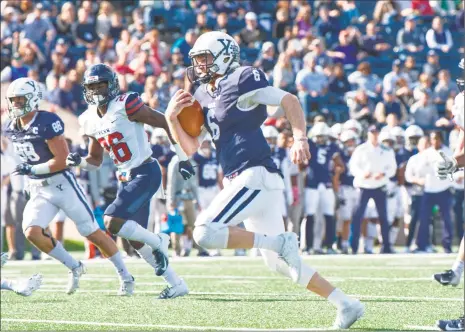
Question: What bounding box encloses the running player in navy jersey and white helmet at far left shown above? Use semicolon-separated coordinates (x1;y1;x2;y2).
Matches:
3;78;134;295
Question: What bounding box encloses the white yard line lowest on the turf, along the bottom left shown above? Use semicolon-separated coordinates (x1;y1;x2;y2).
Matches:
1;318;330;332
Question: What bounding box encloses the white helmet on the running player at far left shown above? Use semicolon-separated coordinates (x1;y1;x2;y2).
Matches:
6;77;42;119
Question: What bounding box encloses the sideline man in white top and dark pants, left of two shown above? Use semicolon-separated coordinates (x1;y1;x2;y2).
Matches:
349;125;397;254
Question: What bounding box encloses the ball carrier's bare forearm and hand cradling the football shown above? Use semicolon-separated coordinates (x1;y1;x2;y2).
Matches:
165;90;200;156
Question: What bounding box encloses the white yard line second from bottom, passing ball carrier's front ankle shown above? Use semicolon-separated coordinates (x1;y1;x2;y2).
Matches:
10;288;463;302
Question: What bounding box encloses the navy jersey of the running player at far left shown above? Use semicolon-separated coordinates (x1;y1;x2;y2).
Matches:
3;111;65;179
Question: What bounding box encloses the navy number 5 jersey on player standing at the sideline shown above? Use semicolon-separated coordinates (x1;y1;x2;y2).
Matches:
306;139;339;189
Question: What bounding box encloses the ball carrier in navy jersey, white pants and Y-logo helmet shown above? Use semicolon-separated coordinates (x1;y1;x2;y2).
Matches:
165;31;364;328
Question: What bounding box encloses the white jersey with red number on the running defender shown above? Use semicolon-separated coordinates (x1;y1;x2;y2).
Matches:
79;92;152;172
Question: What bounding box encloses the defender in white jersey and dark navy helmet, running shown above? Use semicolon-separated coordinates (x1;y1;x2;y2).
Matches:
68;64;195;299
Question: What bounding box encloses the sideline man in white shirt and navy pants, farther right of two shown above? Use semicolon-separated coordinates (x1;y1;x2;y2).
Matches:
415;132;452;253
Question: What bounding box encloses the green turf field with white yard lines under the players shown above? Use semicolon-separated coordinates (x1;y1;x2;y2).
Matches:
1;254;464;331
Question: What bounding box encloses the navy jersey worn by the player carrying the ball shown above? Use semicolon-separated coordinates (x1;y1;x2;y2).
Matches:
194;66;279;177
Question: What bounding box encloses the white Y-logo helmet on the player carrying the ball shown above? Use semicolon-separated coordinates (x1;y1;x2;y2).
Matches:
187;31;240;83
